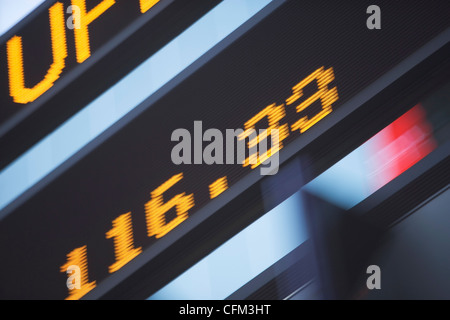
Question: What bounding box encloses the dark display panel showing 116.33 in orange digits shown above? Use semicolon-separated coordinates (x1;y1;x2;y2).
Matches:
0;1;449;299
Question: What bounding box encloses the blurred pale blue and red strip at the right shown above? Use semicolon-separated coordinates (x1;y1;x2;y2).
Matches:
304;104;437;209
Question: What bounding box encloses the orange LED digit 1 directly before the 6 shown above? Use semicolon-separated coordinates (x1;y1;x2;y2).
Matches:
106;212;142;273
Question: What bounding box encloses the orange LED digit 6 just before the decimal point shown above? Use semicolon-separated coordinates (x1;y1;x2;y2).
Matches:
145;173;194;238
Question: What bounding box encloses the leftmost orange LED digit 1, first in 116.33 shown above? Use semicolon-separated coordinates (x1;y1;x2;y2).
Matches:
61;246;96;300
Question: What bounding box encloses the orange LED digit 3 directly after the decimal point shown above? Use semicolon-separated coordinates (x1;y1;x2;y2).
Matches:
239;103;289;169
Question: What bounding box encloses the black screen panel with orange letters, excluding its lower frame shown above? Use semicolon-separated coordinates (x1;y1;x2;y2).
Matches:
0;0;170;111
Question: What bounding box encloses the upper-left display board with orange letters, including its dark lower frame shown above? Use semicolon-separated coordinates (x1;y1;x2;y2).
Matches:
0;0;219;168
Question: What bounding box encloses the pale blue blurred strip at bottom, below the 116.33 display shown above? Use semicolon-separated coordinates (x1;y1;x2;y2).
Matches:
148;192;308;300
